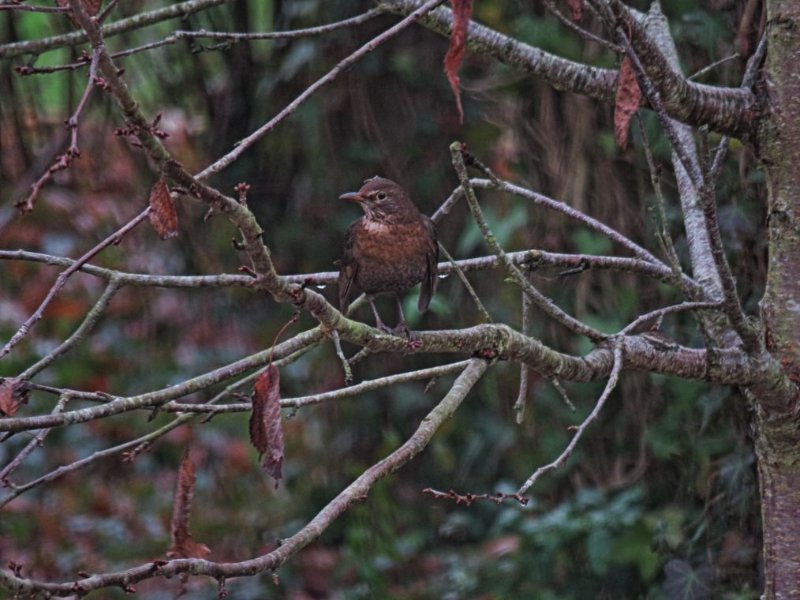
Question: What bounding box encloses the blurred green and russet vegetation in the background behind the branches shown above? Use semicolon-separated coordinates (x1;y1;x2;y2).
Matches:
0;0;765;600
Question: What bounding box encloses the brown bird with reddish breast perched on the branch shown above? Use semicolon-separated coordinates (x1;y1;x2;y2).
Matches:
338;177;439;333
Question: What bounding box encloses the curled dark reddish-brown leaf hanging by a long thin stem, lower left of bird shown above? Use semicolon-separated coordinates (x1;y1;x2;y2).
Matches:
250;364;283;487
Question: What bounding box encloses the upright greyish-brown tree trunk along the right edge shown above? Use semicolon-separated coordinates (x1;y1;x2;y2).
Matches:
756;0;800;599
